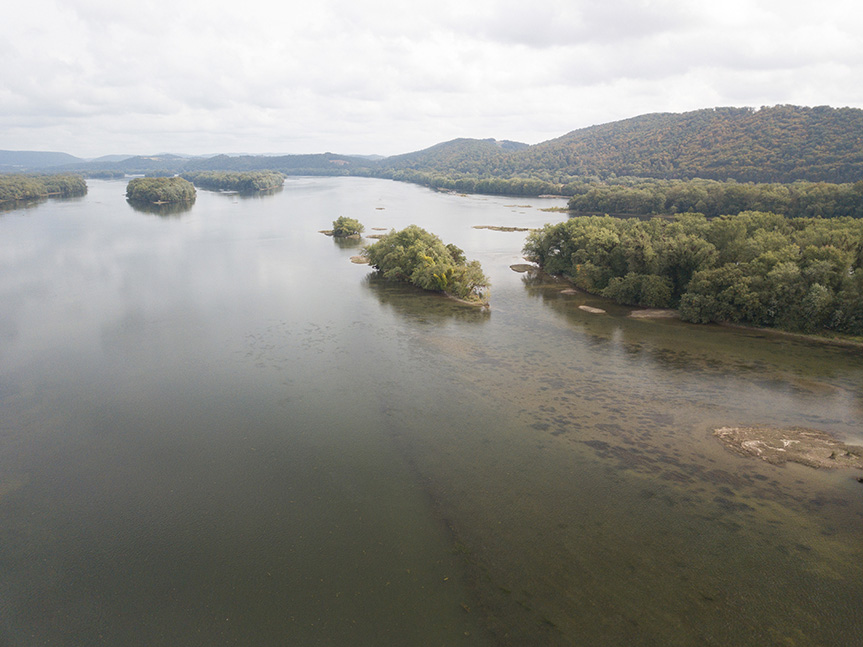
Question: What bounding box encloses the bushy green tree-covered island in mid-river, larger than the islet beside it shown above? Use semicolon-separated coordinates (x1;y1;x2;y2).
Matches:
363;225;490;305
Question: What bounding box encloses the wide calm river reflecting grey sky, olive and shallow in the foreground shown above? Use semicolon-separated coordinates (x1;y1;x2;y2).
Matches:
0;178;863;647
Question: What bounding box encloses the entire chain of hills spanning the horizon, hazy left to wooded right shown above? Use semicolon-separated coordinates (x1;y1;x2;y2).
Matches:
6;106;863;185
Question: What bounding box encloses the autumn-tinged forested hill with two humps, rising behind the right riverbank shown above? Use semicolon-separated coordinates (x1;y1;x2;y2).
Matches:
381;106;863;184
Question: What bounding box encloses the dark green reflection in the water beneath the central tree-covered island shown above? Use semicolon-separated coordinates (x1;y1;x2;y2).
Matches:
363;272;491;324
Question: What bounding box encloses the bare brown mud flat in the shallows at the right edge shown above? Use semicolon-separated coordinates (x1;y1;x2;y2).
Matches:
713;426;863;470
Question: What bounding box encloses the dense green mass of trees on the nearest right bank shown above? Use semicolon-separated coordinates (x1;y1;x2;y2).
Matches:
524;212;863;335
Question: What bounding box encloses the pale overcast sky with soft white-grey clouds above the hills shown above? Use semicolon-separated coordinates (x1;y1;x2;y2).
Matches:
0;0;863;158
